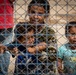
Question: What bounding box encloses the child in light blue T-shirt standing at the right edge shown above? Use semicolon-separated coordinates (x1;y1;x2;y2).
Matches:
58;21;76;75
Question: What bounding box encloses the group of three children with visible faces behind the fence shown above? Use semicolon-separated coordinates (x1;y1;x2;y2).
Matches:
0;0;76;75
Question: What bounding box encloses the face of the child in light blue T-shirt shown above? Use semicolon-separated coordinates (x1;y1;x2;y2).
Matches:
67;26;76;45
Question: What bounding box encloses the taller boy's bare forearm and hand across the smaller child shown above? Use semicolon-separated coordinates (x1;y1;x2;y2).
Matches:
27;42;47;54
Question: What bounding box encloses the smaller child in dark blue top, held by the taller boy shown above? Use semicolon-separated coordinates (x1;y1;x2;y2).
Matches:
8;23;35;75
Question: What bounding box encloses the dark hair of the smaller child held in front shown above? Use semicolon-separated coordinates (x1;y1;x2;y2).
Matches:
14;22;35;39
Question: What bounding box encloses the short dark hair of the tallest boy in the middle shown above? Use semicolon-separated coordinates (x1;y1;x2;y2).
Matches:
28;0;50;14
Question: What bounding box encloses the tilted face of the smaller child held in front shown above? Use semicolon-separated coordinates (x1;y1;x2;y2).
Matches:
18;30;35;45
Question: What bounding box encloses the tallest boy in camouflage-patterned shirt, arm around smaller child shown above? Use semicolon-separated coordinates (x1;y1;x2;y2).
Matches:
14;0;56;75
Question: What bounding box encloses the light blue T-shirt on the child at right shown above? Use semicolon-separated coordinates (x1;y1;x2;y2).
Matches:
58;44;76;75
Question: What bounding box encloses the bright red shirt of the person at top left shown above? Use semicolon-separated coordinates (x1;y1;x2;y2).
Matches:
0;0;14;29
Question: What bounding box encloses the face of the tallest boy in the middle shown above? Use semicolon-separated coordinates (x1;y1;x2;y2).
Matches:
28;5;45;25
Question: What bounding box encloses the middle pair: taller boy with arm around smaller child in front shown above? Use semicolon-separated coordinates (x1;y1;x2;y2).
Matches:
12;0;56;75
